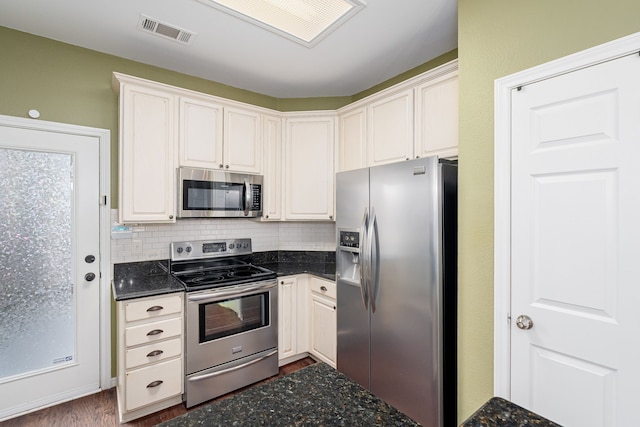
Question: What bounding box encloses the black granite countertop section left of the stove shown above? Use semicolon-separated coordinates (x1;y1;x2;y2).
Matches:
111;261;184;301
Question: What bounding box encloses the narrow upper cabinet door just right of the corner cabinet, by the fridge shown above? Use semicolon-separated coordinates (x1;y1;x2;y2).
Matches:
338;107;367;171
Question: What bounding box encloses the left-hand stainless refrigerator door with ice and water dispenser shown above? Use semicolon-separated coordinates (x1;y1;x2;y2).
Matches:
336;169;369;388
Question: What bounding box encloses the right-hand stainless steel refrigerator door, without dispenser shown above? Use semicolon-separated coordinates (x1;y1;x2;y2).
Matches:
370;158;441;427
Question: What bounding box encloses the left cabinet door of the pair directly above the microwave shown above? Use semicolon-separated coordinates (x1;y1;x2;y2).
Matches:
179;97;223;169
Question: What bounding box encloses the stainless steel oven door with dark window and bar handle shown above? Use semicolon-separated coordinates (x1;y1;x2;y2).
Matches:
185;279;278;374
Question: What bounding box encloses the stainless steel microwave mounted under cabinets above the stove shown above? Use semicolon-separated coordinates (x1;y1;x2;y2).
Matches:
178;167;263;218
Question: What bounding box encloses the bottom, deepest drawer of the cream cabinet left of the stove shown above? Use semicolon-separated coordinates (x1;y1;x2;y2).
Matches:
125;359;184;411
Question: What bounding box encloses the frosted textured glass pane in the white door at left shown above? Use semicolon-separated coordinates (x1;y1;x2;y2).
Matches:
0;149;75;378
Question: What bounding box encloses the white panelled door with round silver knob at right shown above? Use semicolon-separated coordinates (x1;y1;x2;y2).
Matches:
511;54;640;427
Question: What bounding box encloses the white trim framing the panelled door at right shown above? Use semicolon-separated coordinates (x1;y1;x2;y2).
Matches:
493;33;640;399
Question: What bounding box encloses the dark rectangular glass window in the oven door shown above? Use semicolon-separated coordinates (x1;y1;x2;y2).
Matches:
199;292;269;343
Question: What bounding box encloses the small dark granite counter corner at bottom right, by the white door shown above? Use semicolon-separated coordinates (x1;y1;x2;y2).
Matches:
461;397;561;427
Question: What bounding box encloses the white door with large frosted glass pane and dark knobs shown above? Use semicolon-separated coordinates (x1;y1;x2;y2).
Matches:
0;124;100;420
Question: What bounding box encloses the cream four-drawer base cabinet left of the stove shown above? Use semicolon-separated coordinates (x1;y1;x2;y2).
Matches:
117;292;184;423
